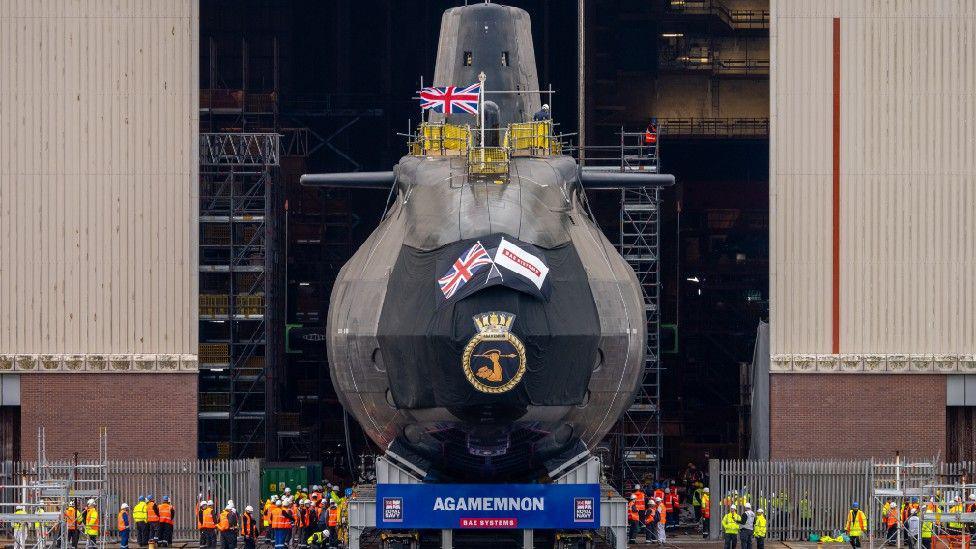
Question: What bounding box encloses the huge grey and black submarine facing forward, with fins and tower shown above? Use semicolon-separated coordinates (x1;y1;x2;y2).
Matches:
301;3;674;483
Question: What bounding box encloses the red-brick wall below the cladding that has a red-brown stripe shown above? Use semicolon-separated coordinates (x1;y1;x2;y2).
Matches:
769;374;946;459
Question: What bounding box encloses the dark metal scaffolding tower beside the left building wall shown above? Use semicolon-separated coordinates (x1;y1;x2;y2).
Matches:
199;133;280;457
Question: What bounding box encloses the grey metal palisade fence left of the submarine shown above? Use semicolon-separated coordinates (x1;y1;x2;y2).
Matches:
0;459;261;540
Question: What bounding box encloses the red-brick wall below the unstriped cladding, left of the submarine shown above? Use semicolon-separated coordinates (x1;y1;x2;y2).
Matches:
20;373;197;459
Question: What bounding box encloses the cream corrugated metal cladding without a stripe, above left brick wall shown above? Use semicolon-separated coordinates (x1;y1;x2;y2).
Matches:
0;0;199;355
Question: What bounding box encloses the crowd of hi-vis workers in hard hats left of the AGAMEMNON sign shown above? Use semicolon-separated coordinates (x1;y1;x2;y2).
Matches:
3;484;352;549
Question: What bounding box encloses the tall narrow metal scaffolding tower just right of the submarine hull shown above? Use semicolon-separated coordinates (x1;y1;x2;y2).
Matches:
618;128;663;482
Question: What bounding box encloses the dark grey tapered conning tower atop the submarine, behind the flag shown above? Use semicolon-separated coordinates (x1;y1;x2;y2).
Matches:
431;3;542;127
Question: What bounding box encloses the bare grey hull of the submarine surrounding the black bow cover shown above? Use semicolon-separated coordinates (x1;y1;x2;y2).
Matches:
328;157;646;480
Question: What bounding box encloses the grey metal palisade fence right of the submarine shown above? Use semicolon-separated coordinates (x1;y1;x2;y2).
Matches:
709;460;976;540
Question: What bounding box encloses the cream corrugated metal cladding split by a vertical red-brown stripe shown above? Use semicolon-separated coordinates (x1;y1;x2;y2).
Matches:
770;0;976;355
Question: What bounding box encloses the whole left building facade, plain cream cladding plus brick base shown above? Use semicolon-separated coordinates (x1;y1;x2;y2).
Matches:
0;0;199;459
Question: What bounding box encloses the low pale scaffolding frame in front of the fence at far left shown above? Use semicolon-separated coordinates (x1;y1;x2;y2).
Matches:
0;427;111;549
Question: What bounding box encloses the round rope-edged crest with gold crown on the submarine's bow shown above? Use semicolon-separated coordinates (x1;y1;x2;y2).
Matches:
462;311;525;394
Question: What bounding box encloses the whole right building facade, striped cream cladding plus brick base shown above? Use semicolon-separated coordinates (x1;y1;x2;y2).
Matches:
770;0;976;460
